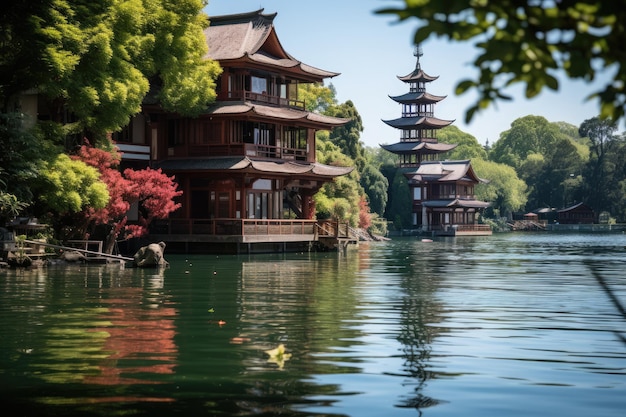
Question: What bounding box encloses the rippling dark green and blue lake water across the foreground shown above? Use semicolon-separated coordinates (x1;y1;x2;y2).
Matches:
0;233;626;417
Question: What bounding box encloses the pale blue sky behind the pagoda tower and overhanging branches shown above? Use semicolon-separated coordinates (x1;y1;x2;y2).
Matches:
205;0;609;147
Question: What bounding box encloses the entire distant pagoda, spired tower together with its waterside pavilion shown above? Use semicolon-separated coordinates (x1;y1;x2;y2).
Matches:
381;46;491;236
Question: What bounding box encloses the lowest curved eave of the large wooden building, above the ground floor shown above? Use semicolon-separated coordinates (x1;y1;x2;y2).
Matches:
157;157;354;179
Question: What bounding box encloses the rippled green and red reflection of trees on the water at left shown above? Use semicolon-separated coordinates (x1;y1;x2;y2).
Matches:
2;265;177;410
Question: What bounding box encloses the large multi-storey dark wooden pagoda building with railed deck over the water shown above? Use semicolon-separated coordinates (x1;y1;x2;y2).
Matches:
118;9;353;253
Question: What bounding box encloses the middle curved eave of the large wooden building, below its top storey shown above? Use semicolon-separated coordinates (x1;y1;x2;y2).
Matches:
204;102;350;128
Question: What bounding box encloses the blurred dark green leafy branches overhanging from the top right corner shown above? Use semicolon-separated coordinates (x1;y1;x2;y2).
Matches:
376;0;626;125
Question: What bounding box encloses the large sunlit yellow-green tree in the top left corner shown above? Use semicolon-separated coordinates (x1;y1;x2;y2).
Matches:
0;0;221;139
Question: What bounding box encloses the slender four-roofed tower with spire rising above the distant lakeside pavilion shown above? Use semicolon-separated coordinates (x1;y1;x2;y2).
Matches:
381;45;456;167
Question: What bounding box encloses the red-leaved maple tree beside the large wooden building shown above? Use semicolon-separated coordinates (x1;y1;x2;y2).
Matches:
74;144;183;253
